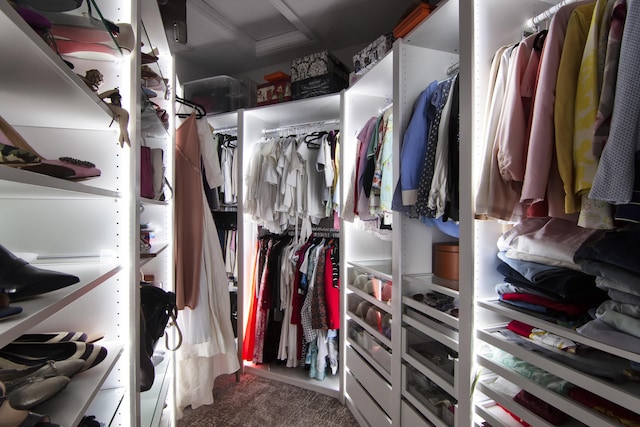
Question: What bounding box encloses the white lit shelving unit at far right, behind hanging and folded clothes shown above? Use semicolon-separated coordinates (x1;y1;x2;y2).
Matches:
461;0;640;426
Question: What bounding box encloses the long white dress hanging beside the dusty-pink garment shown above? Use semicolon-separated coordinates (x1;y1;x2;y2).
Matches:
176;120;240;419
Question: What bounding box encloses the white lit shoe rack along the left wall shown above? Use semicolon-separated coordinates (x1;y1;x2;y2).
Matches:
0;0;173;426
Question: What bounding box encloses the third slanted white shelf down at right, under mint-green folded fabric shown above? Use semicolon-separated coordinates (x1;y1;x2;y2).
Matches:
478;355;611;426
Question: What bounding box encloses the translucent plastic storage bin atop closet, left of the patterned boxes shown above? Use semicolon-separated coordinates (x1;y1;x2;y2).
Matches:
183;75;256;115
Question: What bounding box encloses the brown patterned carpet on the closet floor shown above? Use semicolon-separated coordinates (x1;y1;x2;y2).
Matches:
178;374;358;427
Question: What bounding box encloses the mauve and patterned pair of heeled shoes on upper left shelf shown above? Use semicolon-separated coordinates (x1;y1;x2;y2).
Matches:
0;116;101;180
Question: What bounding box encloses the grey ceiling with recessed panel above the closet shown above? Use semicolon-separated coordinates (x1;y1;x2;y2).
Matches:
158;0;420;83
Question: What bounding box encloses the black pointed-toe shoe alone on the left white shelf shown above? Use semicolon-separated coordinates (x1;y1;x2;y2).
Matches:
0;245;80;301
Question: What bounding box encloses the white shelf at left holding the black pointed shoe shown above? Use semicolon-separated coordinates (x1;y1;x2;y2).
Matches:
0;263;122;346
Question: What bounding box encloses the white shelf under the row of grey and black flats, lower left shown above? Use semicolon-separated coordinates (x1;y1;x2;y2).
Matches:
35;341;123;426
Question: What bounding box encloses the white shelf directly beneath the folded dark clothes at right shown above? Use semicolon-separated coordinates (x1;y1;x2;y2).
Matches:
478;298;640;363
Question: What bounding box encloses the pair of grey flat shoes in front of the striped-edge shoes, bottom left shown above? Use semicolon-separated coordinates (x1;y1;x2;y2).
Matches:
0;359;84;409
